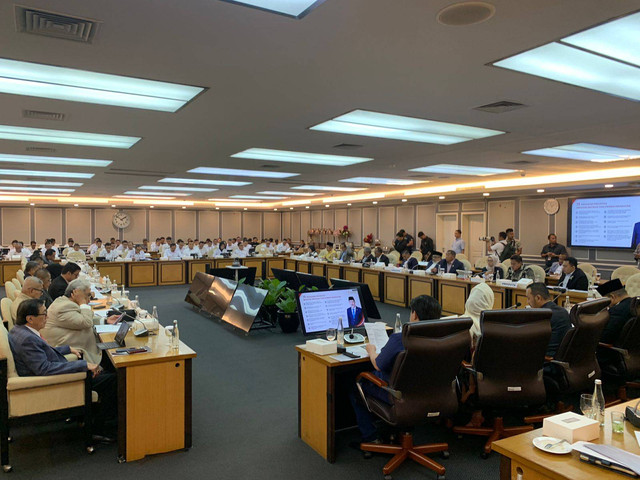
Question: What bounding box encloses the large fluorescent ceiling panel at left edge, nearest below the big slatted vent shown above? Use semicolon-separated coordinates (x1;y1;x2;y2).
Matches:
0;58;204;112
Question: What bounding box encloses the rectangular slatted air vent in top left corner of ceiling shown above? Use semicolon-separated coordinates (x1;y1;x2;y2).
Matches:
15;5;102;43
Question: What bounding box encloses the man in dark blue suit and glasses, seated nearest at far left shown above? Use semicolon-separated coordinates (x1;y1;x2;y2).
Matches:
9;299;118;443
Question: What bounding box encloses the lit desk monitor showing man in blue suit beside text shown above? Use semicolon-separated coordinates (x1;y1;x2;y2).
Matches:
298;287;367;335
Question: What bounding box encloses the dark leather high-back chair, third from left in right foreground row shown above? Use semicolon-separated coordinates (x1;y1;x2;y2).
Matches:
551;298;611;395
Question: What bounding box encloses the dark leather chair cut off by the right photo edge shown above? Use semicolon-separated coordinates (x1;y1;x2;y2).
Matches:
597;297;640;402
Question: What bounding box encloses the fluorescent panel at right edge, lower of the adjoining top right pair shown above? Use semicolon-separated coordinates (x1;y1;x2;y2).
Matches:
494;43;640;101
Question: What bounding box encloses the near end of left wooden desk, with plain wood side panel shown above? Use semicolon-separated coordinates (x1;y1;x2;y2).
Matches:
101;328;196;462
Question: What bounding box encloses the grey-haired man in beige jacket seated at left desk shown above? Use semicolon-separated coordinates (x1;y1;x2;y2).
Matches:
41;279;118;364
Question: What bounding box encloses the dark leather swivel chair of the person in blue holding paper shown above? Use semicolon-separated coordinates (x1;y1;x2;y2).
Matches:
357;318;472;479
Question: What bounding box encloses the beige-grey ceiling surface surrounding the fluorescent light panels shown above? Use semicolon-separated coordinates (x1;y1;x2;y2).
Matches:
0;0;640;204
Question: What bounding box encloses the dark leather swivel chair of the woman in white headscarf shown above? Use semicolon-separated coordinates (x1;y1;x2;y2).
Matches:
453;308;551;458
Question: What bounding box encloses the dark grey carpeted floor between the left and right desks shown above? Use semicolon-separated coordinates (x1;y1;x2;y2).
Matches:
5;285;499;480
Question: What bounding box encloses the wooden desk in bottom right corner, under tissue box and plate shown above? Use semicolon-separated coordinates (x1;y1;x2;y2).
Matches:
493;400;640;480
